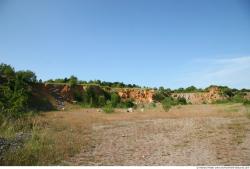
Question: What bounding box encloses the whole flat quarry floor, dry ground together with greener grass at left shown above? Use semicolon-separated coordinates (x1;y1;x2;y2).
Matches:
0;104;250;165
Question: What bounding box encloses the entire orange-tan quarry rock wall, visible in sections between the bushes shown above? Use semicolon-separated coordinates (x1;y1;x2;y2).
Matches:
31;84;227;110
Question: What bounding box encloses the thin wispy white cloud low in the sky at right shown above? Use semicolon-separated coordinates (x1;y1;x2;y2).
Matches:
182;56;250;88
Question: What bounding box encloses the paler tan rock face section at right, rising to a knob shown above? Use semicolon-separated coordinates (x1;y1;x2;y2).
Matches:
172;87;224;104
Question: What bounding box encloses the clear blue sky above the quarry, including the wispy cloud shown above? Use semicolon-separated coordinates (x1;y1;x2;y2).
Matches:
0;0;250;89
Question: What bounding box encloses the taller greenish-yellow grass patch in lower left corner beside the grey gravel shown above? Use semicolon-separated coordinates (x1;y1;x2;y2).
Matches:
0;112;87;165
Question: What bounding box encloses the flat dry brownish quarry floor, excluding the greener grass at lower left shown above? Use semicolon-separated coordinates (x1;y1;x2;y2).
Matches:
43;104;250;165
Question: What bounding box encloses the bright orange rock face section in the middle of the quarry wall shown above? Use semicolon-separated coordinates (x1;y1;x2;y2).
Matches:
116;88;155;103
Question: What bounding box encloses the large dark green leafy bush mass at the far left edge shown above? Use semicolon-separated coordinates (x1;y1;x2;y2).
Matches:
0;64;37;118
